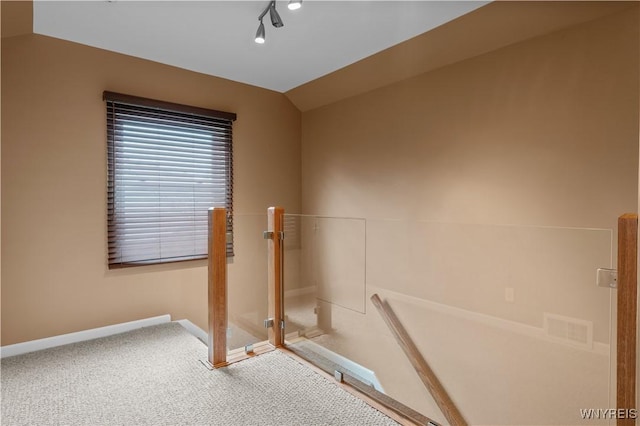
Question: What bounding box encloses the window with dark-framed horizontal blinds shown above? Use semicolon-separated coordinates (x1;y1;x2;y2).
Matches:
103;92;236;268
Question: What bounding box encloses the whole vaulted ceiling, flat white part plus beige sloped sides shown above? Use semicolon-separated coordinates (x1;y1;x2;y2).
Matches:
2;0;634;111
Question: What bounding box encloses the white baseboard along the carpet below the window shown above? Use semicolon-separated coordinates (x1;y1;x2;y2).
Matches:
0;314;171;358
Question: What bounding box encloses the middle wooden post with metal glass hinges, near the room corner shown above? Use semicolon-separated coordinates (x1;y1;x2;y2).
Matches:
267;207;284;347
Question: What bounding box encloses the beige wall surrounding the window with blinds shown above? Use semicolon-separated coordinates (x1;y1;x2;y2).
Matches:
2;35;300;345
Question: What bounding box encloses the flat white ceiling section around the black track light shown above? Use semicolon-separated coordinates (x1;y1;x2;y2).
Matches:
33;0;488;92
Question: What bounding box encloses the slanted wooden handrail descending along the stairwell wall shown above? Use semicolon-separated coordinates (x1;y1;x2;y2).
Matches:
371;294;467;426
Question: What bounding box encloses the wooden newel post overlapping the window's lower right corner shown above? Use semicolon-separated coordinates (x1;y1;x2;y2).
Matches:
207;207;227;368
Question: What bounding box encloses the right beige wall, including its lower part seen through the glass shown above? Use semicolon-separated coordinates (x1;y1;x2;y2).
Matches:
302;6;639;424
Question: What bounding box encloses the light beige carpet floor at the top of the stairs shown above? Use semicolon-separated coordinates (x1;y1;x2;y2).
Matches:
0;323;397;426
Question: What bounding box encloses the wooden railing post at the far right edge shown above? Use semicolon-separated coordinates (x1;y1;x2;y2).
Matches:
616;213;638;426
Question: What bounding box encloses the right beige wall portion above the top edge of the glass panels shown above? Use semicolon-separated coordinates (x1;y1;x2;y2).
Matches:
302;7;638;228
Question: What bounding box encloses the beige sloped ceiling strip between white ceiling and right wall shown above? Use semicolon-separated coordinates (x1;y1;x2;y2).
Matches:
285;0;637;112
